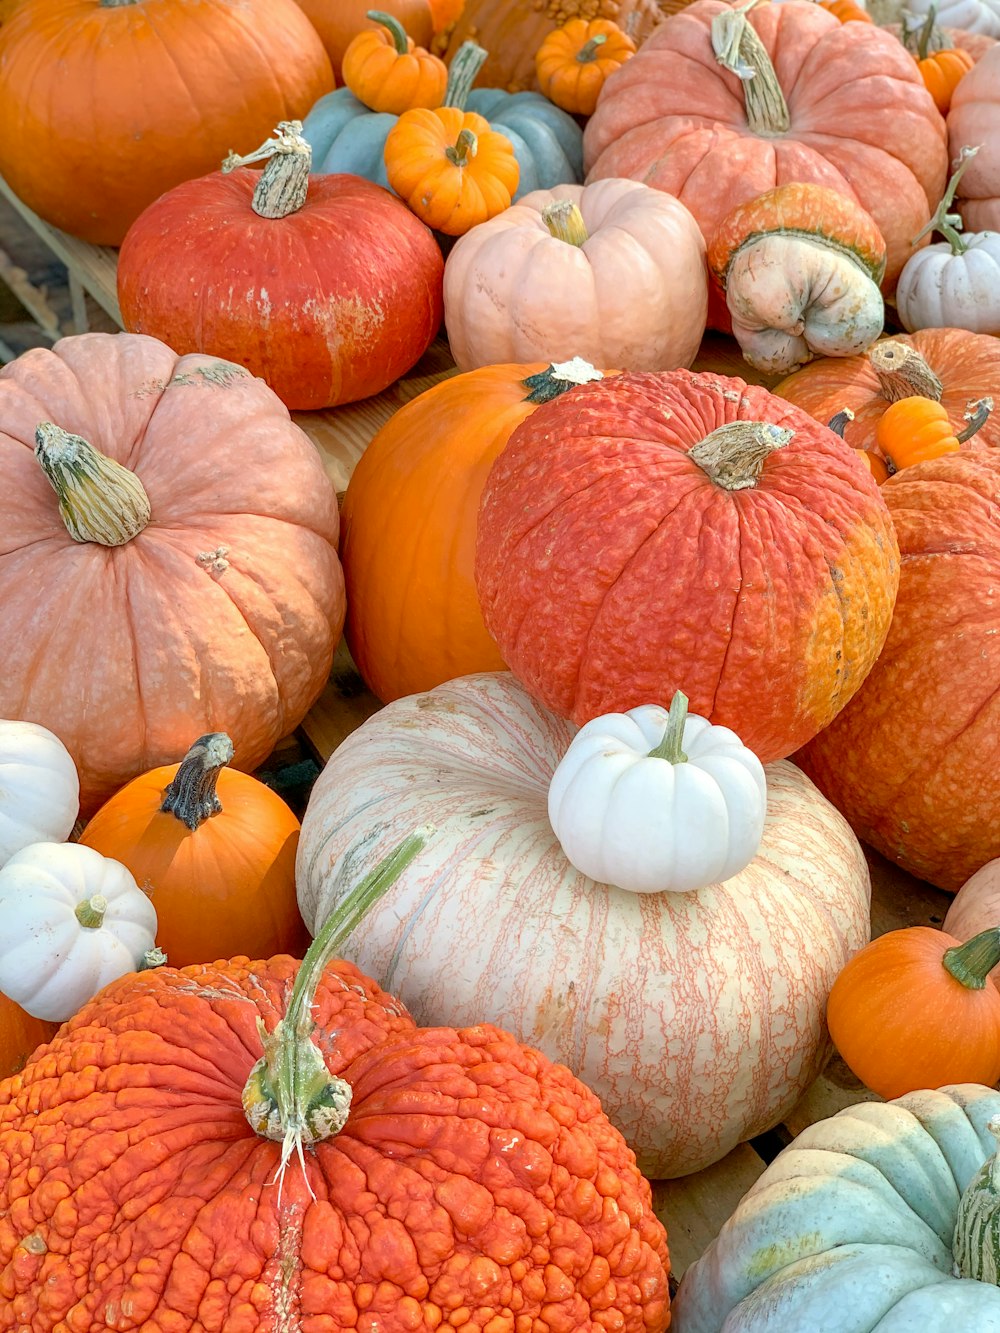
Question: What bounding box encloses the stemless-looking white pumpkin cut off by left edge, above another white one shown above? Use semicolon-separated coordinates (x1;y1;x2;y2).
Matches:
0;721;80;866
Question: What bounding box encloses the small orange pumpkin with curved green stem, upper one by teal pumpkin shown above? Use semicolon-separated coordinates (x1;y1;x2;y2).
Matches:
341;9;448;116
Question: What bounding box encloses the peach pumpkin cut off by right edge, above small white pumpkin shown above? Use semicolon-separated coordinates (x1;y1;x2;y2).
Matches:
948;45;1000;232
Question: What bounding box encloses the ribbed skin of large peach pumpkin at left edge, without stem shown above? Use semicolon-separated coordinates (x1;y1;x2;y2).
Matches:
0;333;344;816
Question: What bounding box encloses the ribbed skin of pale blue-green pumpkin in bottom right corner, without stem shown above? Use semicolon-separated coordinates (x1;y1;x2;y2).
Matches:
671;1084;1000;1333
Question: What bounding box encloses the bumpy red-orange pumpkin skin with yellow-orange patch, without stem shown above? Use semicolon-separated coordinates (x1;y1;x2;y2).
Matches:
476;371;899;764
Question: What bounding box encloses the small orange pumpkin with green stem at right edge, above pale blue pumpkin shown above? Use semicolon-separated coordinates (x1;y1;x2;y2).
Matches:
827;925;1000;1100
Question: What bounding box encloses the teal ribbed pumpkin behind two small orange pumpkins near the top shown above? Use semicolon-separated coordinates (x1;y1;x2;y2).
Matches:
303;41;583;199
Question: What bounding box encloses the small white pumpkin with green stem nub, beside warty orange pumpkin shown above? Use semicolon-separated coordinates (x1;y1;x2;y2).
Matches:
0;842;156;1022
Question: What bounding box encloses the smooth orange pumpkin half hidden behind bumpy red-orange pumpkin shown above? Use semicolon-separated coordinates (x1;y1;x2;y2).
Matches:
340;361;610;704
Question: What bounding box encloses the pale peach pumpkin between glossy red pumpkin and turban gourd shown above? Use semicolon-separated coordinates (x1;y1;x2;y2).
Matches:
444;180;708;371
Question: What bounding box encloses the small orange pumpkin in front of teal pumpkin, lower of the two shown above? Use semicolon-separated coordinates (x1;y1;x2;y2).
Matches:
385;107;521;236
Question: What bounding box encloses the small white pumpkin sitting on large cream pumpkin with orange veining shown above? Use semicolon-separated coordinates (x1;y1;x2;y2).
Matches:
548;690;767;893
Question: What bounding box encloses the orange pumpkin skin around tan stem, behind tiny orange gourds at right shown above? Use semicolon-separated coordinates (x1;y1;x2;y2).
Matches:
775;328;1000;449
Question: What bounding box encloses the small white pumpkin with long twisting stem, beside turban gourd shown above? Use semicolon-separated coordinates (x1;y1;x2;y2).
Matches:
896;148;1000;335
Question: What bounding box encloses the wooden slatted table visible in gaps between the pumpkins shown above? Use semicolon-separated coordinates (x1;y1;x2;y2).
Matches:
0;171;951;1280
